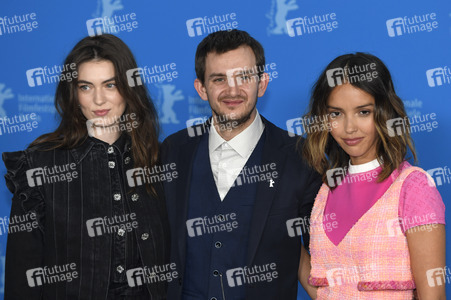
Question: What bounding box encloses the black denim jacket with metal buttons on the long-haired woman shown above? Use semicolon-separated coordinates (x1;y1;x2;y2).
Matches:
3;136;169;300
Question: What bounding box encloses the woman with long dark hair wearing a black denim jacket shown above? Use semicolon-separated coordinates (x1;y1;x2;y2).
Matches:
3;34;169;299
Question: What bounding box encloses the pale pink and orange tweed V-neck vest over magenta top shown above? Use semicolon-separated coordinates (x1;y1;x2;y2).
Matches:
309;167;420;300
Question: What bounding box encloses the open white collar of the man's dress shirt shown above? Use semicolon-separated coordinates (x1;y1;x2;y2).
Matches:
208;111;265;158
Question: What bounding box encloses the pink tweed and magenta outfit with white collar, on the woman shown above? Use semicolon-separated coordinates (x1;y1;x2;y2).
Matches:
309;160;445;300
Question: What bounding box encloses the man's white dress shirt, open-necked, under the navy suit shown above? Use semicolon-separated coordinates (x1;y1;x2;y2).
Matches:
208;111;265;201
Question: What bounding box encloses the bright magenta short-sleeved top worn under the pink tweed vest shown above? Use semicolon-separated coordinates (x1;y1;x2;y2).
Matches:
323;162;445;246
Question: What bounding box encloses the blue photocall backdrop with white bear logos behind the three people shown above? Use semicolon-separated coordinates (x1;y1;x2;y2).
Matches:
0;0;451;299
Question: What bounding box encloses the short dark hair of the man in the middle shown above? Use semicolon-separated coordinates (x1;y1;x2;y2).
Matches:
195;29;265;84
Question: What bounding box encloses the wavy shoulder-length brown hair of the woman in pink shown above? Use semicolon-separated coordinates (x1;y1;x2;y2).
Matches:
303;52;416;188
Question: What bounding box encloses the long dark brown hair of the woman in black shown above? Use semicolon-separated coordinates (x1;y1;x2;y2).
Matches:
30;34;160;190
